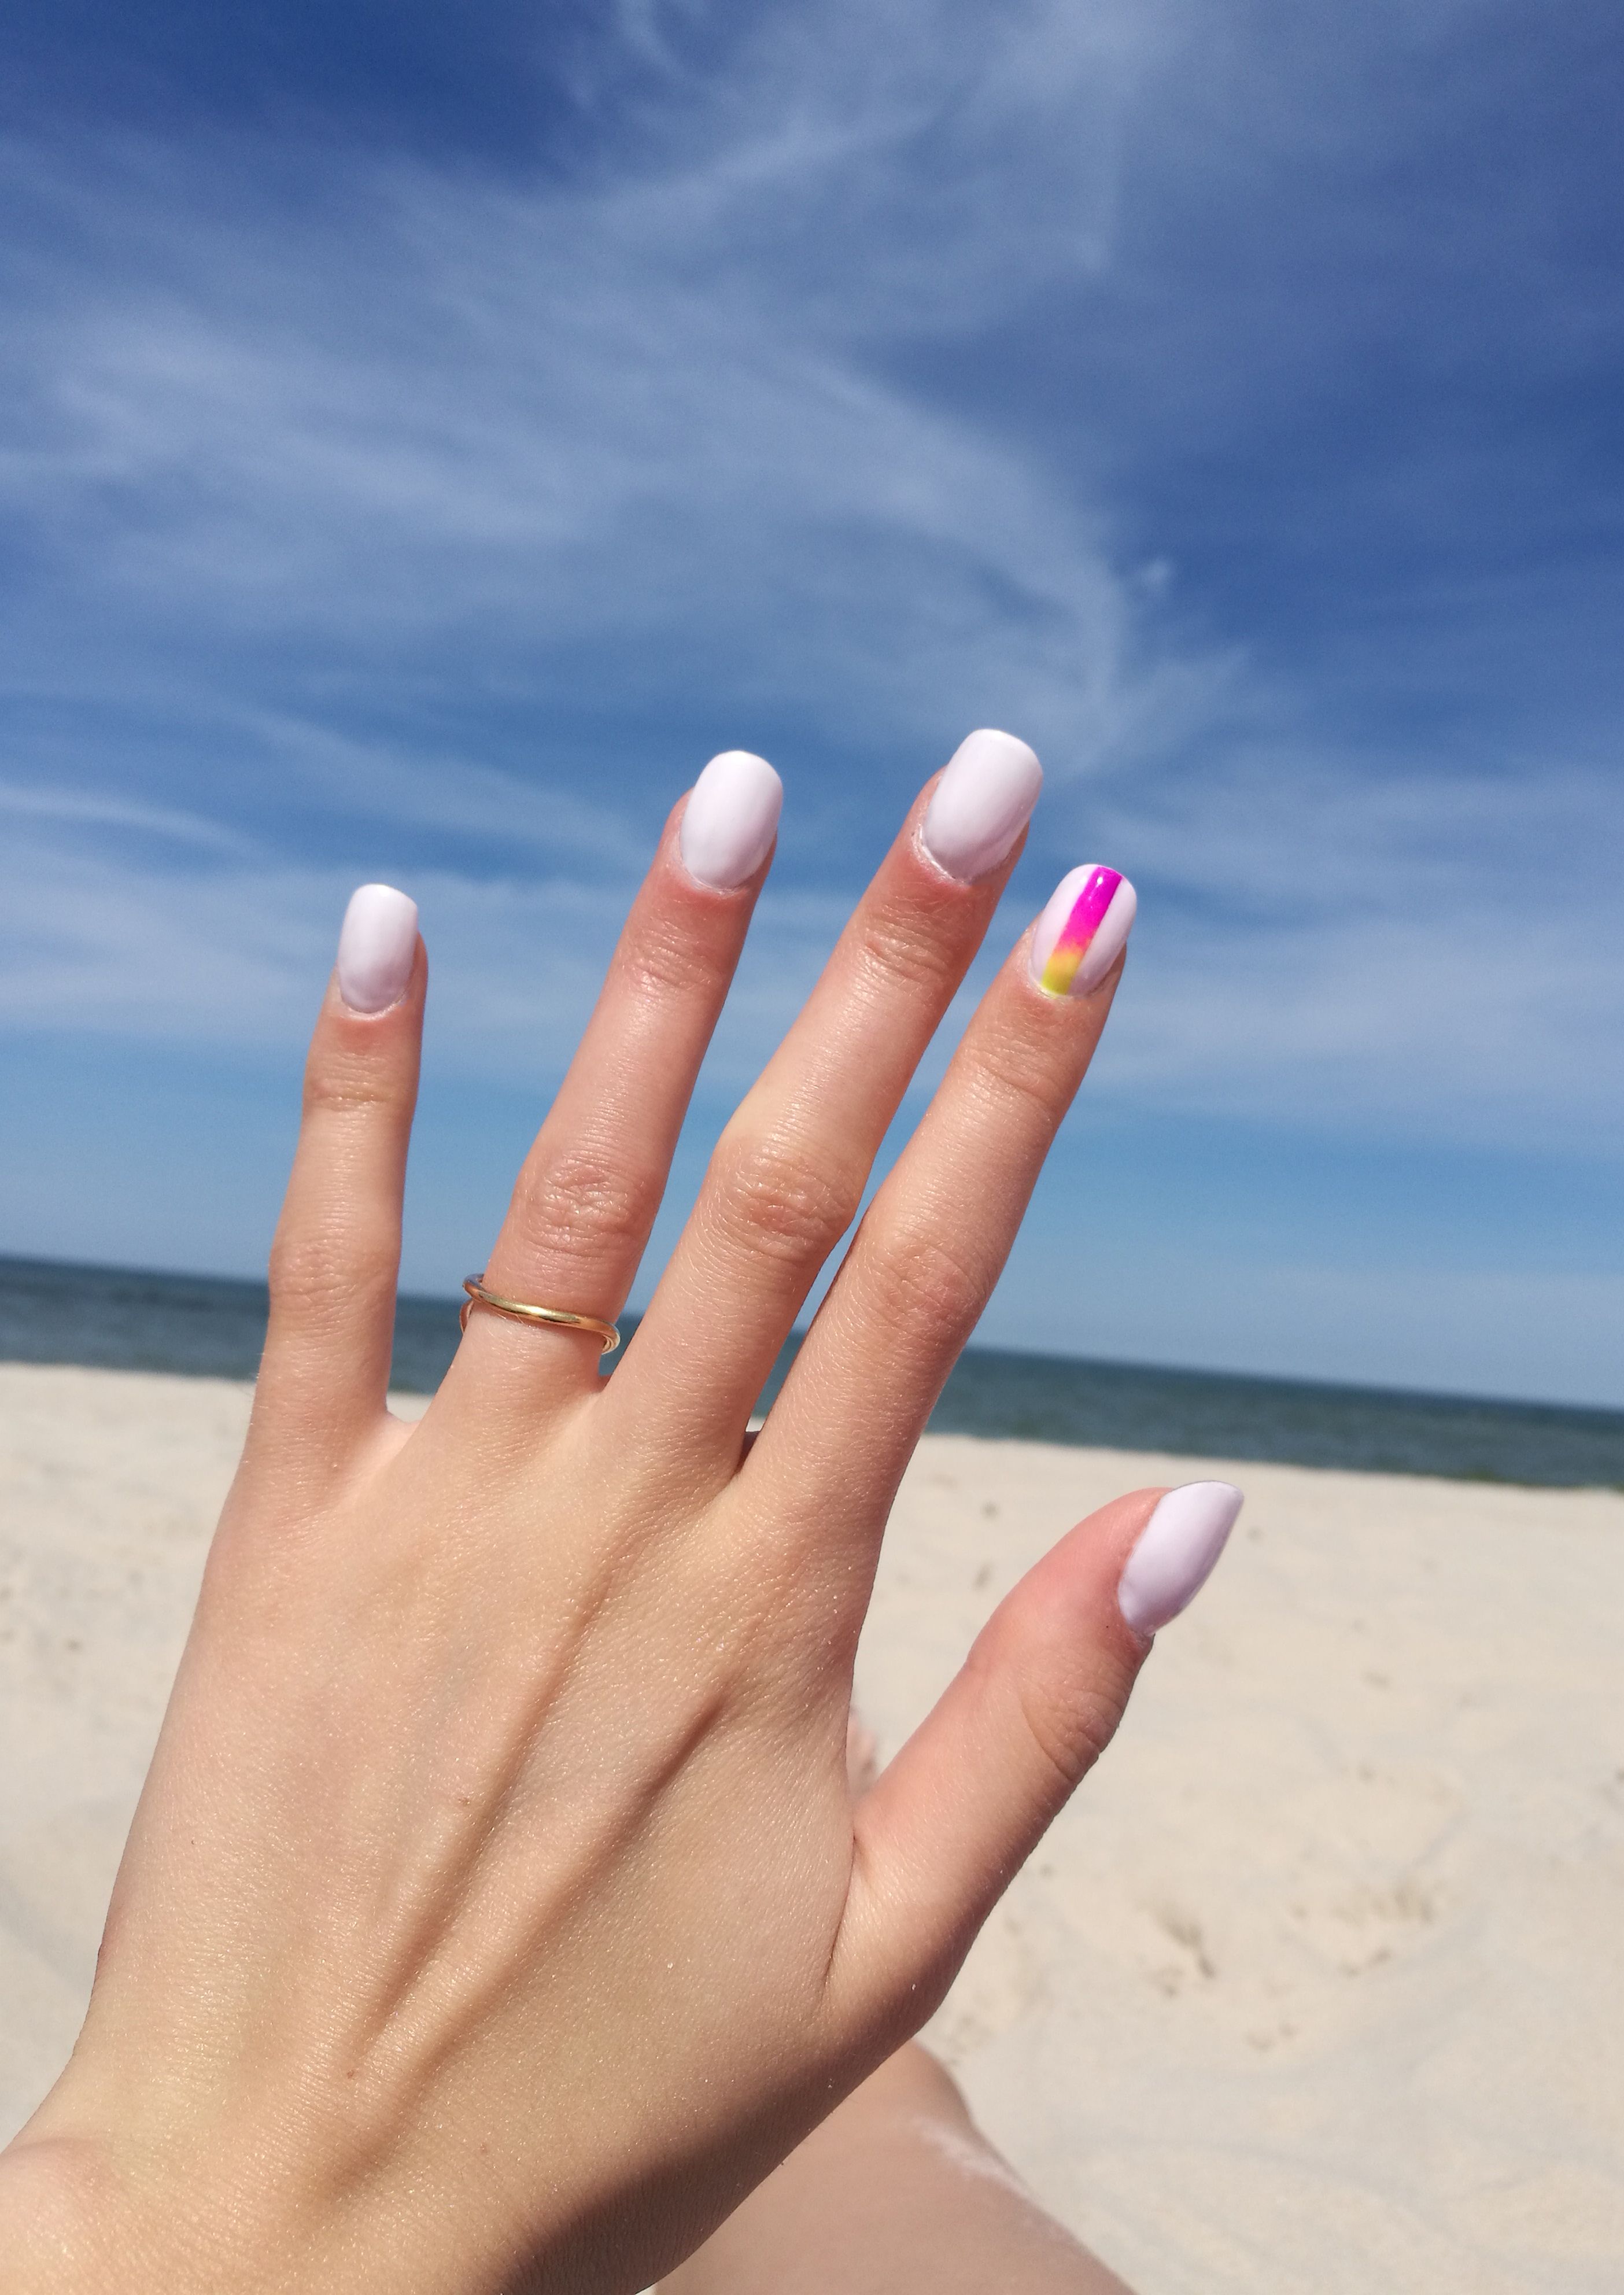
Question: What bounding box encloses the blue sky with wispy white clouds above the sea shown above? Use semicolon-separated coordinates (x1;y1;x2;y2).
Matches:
0;0;1624;1402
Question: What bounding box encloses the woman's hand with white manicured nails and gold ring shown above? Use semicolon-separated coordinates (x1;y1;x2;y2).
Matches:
0;735;1239;2295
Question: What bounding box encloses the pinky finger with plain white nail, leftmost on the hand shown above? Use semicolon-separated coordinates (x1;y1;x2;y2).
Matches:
254;884;429;1464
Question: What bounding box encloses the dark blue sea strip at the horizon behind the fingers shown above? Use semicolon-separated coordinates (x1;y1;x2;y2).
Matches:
0;1257;1624;1489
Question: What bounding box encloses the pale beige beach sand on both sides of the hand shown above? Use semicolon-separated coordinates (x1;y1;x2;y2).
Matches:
0;1366;1624;2295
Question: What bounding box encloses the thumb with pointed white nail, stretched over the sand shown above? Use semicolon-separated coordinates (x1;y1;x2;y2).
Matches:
831;1482;1241;2029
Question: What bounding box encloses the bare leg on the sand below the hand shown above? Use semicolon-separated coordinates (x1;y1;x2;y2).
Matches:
658;2045;1128;2295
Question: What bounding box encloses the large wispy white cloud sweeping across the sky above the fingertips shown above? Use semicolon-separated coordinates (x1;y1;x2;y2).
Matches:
0;0;1216;759
